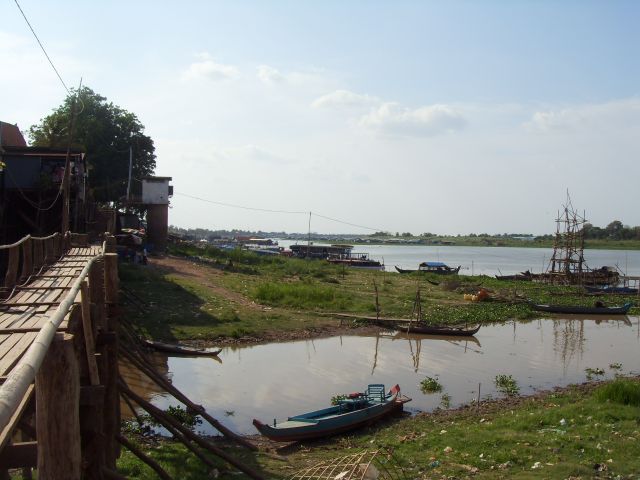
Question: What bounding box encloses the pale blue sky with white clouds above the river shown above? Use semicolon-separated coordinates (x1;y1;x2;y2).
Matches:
0;0;640;234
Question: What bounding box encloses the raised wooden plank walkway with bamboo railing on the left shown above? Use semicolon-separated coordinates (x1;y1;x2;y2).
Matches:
0;239;119;478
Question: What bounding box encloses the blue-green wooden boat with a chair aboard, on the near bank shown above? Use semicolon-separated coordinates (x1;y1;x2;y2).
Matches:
253;384;411;442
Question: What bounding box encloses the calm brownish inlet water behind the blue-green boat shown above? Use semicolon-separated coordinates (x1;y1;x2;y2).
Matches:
129;316;640;434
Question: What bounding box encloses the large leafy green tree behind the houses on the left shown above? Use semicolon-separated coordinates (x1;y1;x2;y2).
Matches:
29;87;156;202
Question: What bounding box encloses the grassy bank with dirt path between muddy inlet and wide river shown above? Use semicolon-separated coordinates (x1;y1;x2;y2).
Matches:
120;247;635;341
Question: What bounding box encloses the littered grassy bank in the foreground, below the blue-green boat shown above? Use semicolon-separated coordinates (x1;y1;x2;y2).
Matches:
119;378;640;479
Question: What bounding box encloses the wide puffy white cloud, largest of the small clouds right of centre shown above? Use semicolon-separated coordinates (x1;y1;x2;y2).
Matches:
360;102;467;137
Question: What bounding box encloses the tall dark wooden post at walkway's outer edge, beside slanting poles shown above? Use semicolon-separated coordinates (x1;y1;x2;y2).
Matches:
102;253;120;470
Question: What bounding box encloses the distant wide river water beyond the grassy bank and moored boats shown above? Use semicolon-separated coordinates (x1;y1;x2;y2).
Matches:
279;240;640;275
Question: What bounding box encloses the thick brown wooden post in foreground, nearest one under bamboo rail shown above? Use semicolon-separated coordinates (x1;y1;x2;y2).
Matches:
36;334;81;480
